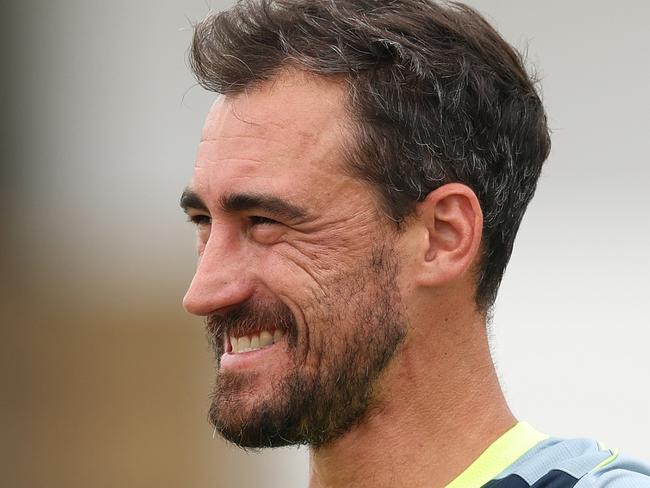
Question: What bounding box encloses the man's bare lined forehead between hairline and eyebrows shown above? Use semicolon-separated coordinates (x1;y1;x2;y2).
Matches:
193;72;348;201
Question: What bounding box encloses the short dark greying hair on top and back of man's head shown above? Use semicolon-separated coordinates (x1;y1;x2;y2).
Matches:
190;0;550;311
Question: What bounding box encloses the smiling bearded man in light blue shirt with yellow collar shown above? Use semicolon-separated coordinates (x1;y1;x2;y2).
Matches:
181;0;650;488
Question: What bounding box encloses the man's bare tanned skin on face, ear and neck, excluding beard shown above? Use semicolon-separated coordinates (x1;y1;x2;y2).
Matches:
184;71;516;488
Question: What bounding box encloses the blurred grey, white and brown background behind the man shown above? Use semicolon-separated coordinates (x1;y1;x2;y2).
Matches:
0;0;650;488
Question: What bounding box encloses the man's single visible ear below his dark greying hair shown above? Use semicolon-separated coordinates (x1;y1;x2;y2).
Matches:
416;183;483;286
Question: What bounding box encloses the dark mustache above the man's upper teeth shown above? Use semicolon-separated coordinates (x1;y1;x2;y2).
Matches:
206;301;298;350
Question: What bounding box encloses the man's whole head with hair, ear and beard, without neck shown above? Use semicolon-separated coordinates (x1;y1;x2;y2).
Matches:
183;0;550;447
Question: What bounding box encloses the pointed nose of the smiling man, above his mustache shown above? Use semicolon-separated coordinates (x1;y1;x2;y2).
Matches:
183;233;252;316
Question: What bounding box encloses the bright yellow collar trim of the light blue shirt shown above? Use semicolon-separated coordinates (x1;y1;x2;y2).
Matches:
446;422;549;488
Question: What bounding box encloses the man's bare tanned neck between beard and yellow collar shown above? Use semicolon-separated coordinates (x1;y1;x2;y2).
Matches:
309;306;516;488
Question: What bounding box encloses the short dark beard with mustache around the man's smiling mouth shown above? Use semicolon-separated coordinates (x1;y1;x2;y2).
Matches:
207;242;406;448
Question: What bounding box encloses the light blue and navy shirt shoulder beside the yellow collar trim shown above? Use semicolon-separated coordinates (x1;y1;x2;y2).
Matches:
486;438;650;488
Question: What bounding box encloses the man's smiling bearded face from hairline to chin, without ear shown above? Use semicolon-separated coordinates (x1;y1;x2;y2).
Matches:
183;73;406;447
